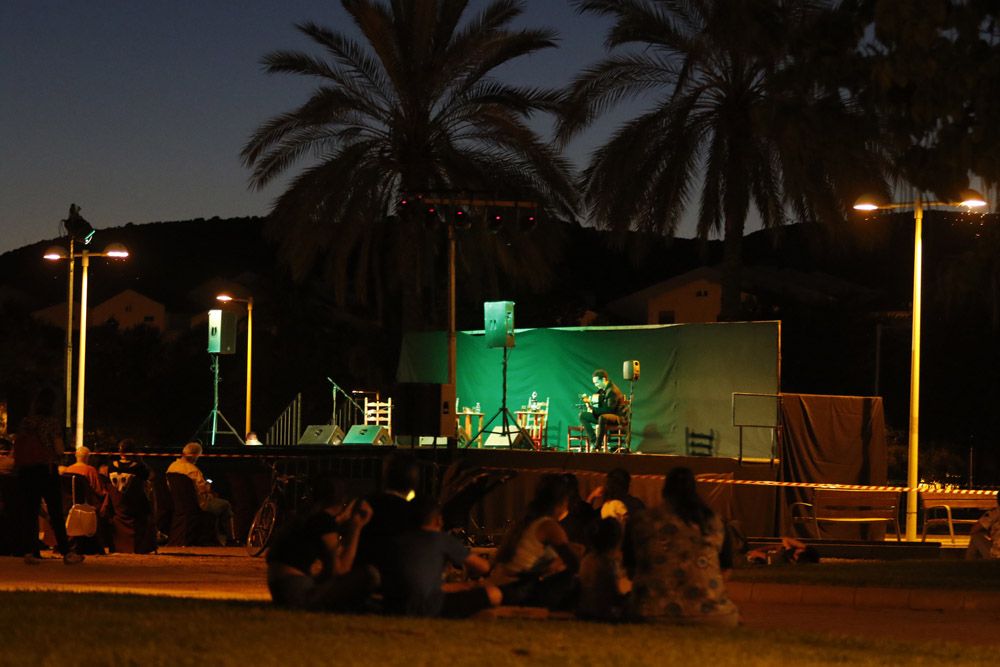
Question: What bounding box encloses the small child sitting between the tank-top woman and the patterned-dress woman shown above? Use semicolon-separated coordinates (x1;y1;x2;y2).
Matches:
576;517;632;621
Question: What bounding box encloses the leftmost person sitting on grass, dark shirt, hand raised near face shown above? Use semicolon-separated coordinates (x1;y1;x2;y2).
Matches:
267;476;378;611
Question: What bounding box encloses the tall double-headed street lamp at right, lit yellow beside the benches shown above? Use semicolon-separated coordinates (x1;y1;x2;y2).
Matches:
854;190;986;541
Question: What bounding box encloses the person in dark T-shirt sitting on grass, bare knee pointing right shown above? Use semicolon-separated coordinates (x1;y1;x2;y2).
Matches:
382;498;503;618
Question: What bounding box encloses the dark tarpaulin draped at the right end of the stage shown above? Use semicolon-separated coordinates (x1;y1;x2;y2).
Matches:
781;394;887;540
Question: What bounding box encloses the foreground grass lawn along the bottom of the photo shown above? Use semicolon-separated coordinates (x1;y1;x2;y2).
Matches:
0;592;996;667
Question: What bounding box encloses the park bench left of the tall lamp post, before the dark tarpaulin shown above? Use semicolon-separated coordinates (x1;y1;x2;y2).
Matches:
790;488;901;542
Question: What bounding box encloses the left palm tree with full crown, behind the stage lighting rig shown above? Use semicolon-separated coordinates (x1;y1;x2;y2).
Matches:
242;0;574;325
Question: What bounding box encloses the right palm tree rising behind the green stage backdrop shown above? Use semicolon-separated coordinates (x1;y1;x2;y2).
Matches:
558;0;882;319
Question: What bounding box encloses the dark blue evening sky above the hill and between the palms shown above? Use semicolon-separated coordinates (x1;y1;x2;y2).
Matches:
0;0;652;252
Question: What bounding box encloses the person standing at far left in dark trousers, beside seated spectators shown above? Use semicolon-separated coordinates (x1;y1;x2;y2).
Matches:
14;387;83;565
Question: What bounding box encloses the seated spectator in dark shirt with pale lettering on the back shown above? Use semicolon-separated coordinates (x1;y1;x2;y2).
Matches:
108;438;156;553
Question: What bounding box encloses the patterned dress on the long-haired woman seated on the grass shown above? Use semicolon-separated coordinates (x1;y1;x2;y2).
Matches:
632;504;739;625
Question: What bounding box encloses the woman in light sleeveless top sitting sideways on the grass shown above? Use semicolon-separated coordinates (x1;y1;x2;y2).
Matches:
490;473;582;609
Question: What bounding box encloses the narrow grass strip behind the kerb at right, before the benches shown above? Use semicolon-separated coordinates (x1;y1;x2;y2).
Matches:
732;560;1000;592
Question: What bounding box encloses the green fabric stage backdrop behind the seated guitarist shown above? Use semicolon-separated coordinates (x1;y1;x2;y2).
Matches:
397;322;780;458
